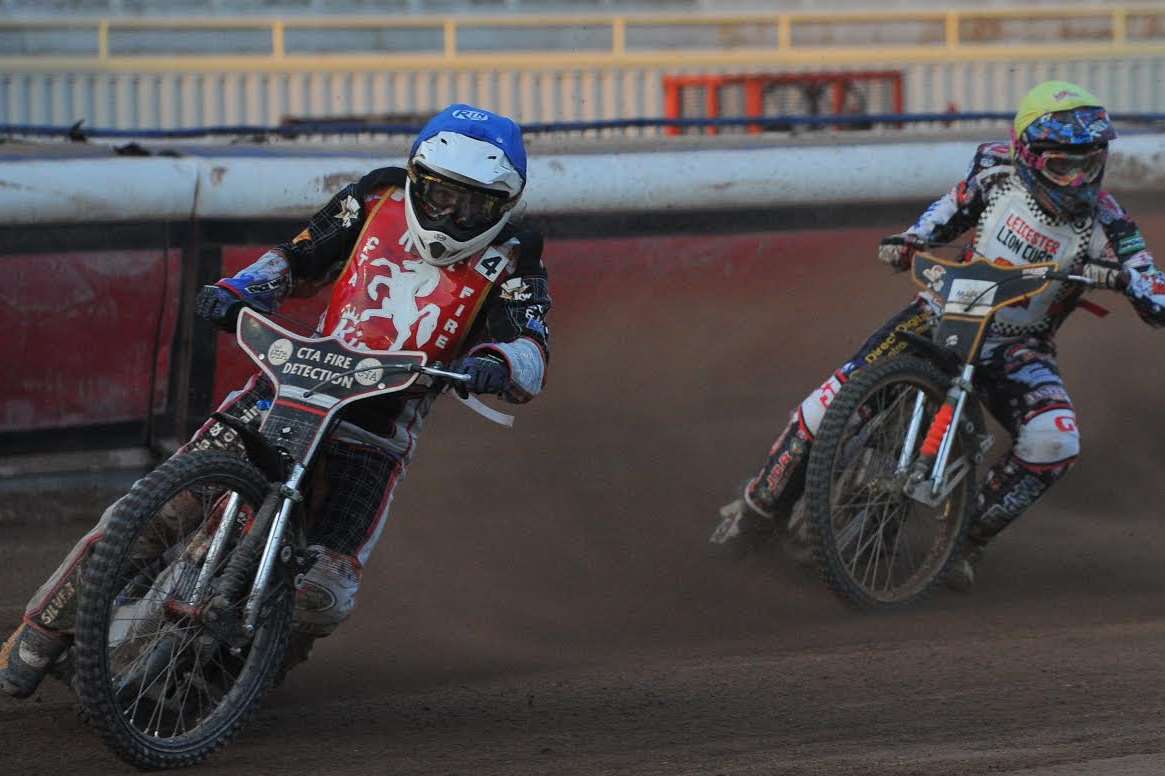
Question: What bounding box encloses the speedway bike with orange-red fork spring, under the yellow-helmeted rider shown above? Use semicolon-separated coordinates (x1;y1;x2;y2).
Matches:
803;244;1092;609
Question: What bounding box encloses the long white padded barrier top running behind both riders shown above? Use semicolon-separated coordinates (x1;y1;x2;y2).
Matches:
0;135;1165;226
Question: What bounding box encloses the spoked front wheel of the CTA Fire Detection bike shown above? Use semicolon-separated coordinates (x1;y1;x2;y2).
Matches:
76;452;292;769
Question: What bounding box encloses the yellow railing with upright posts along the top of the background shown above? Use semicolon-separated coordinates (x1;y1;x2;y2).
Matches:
0;2;1165;75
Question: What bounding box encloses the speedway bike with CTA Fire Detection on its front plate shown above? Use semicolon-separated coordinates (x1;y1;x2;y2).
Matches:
73;309;468;769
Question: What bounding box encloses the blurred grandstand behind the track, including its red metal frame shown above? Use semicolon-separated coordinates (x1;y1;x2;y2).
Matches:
0;0;1165;134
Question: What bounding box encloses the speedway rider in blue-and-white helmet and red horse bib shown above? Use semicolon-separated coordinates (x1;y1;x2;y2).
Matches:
0;105;550;698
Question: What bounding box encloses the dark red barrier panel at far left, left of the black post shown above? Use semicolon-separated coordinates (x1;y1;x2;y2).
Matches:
0;251;179;431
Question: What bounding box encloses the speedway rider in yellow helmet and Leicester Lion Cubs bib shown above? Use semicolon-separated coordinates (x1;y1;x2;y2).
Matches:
709;82;1165;590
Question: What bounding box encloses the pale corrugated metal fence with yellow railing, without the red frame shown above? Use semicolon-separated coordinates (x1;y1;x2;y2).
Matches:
0;3;1165;132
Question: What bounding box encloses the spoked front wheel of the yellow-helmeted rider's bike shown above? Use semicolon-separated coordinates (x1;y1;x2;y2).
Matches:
805;355;979;608
